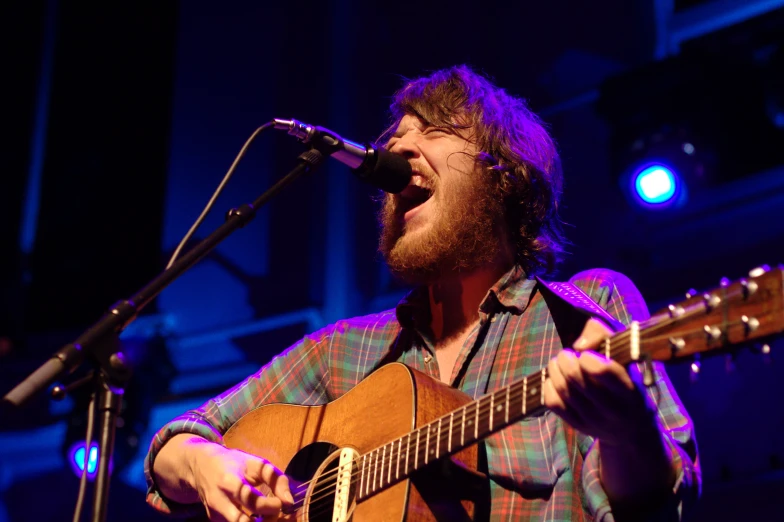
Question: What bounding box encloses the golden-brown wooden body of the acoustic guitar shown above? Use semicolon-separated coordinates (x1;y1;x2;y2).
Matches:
224;363;487;522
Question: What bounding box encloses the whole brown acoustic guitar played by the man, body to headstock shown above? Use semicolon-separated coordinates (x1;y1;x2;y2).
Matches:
224;267;784;522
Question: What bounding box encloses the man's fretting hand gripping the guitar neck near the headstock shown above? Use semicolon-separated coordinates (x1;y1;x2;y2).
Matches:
544;319;657;445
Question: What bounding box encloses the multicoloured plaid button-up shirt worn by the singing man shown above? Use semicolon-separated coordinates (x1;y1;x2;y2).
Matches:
145;267;700;522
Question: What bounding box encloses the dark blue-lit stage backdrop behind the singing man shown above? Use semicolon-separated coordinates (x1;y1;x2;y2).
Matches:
0;0;784;522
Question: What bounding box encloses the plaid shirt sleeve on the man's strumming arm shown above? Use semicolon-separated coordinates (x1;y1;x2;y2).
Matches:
144;326;334;516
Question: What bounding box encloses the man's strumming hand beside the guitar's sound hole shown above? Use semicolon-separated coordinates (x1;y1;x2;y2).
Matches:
190;441;294;522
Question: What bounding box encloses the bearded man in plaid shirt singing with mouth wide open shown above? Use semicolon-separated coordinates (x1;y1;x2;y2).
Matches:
146;66;699;521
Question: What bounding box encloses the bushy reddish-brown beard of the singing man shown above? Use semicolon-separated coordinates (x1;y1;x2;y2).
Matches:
379;172;504;284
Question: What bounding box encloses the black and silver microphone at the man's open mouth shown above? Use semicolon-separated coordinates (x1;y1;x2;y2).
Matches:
274;118;411;194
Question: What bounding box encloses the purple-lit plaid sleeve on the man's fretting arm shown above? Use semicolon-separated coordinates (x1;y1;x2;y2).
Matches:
572;270;701;522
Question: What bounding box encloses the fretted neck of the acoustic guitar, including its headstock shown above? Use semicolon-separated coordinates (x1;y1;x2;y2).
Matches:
358;268;784;499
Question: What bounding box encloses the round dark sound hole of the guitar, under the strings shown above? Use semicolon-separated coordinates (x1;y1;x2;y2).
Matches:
286;442;339;522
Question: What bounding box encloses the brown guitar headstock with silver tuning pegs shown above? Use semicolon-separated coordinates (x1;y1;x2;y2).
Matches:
640;267;784;361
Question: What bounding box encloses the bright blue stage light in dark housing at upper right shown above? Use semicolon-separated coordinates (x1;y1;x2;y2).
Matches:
596;44;784;207
